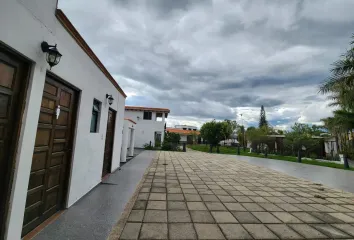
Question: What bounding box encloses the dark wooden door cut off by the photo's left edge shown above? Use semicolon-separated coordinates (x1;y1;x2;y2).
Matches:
0;46;28;239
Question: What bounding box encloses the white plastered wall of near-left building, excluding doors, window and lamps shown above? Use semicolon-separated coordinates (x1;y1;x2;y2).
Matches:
0;0;125;240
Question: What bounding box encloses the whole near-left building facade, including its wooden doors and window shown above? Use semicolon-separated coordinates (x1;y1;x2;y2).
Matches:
0;0;126;240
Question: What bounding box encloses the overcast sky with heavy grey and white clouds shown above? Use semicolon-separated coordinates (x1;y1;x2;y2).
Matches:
59;0;354;128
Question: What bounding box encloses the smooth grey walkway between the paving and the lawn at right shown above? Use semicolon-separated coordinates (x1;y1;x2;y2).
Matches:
236;155;354;193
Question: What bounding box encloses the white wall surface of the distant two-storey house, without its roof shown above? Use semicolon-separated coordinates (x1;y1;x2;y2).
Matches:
124;110;165;148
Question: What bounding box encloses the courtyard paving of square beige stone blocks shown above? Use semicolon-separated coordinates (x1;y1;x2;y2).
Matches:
116;152;354;239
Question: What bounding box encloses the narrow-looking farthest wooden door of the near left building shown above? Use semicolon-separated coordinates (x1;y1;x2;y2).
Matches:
102;109;116;177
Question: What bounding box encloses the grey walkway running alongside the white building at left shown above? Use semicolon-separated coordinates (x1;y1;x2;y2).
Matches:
34;151;155;240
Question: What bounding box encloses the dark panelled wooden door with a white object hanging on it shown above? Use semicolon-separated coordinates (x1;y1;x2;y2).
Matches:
22;76;77;235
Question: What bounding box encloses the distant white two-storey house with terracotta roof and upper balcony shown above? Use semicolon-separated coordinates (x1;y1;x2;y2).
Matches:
124;106;170;148
